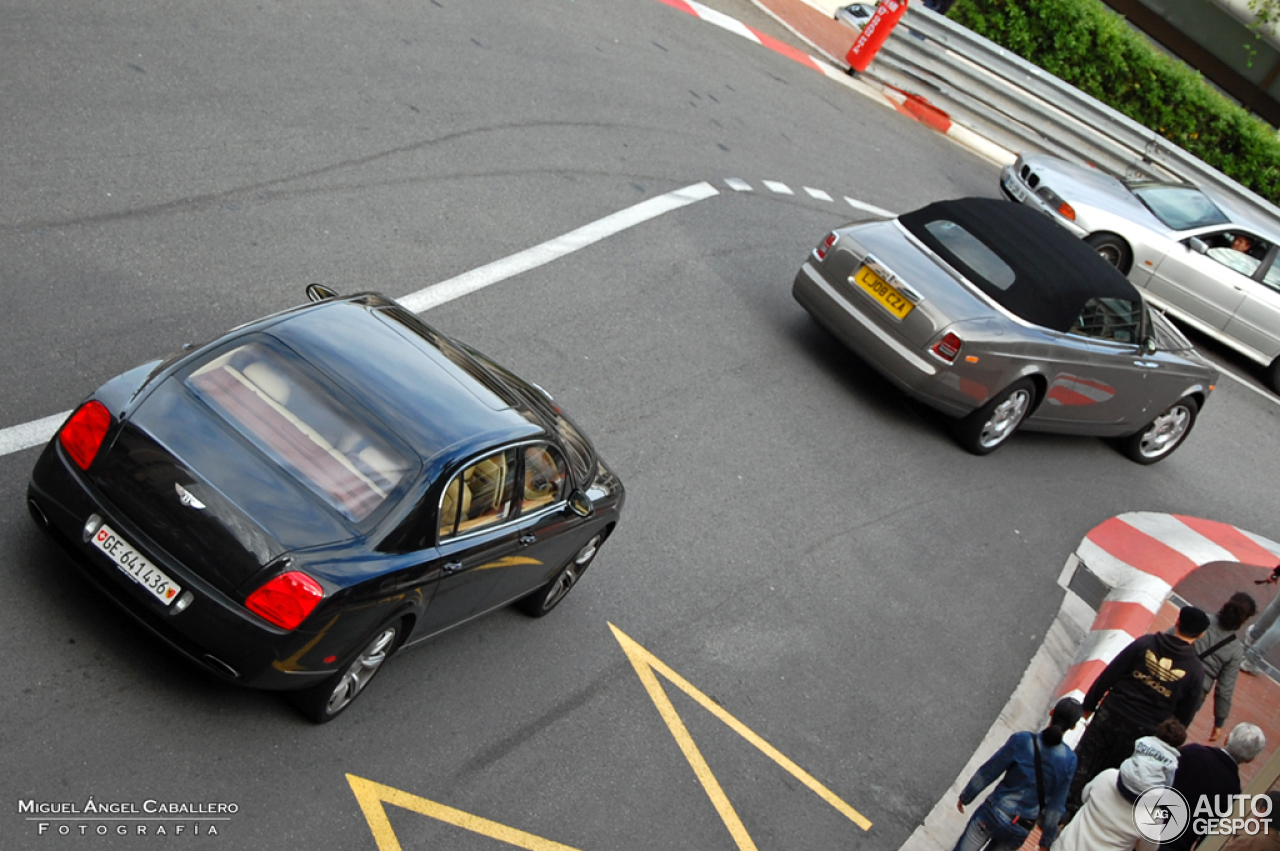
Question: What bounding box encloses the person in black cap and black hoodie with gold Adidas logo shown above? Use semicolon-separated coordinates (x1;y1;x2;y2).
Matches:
1066;605;1208;816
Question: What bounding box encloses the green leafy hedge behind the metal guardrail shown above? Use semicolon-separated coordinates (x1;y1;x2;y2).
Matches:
947;0;1280;203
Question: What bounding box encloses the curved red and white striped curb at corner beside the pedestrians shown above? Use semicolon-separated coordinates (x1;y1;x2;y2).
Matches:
1057;512;1280;699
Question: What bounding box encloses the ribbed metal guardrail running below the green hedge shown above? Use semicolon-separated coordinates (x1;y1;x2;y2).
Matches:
869;5;1280;223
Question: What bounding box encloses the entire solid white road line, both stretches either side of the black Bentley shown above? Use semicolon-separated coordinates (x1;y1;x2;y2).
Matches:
0;180;719;457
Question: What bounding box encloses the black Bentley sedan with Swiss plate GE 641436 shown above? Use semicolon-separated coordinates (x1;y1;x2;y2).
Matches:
28;285;625;722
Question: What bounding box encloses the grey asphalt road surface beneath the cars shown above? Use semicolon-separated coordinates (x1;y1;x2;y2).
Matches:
0;0;1280;851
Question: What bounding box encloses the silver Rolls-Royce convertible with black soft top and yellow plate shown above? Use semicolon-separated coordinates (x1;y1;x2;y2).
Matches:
792;198;1219;465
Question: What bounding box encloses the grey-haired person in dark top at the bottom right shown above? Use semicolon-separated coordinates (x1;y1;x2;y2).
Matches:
1160;724;1267;851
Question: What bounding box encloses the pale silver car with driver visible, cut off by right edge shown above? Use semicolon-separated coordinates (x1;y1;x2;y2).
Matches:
1000;154;1280;393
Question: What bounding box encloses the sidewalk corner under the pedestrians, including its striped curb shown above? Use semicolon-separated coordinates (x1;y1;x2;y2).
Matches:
901;512;1280;851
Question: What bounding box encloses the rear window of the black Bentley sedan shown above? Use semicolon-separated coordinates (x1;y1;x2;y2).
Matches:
186;343;413;521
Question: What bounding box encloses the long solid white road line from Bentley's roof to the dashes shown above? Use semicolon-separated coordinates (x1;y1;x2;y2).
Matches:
397;182;719;314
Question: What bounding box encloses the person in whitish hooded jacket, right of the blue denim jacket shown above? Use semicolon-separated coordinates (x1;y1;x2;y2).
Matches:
1053;718;1187;851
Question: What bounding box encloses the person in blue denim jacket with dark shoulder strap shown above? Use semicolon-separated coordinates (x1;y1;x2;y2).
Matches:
955;697;1083;851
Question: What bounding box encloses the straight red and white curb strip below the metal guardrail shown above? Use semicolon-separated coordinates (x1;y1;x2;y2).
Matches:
658;0;1016;165
